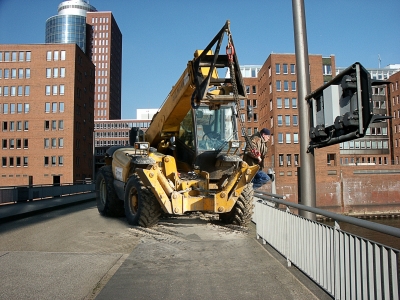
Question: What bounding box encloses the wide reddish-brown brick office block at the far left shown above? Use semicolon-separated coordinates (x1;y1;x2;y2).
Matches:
0;44;95;186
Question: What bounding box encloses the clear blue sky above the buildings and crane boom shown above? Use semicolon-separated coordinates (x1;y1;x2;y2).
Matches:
0;0;400;119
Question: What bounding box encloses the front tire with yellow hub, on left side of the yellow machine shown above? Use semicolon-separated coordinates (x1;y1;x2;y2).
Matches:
124;175;161;227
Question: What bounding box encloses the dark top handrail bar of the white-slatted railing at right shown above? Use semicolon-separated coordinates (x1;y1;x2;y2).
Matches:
254;191;400;238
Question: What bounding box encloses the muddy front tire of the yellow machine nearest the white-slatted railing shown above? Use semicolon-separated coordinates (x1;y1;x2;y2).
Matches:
219;183;254;227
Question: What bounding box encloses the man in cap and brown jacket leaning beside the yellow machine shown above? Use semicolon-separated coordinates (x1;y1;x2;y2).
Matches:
243;128;271;188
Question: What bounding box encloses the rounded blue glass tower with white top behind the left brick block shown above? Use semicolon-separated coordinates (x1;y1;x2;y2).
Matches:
45;0;96;53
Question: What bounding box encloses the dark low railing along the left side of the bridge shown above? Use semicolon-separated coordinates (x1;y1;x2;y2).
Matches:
0;181;95;203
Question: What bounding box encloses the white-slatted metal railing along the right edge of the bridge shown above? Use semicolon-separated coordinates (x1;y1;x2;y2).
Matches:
253;191;400;299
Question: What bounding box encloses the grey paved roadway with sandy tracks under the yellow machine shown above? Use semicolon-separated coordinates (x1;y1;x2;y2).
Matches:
0;201;329;300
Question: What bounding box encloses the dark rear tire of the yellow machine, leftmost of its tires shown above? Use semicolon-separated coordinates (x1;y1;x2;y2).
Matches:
96;166;125;217
